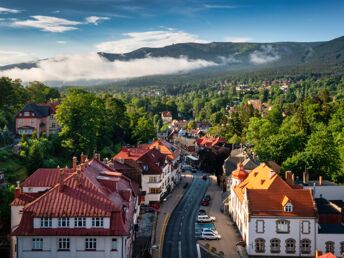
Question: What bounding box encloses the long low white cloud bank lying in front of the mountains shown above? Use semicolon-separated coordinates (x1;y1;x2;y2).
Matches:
0;54;217;82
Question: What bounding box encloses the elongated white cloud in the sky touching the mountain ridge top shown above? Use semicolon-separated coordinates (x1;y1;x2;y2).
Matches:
96;30;207;53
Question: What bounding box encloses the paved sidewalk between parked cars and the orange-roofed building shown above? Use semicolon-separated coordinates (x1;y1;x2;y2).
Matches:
199;176;240;258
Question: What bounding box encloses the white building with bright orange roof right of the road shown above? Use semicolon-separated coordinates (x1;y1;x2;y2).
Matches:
228;163;317;257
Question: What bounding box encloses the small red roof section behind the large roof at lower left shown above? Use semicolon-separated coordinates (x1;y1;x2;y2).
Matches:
21;168;72;187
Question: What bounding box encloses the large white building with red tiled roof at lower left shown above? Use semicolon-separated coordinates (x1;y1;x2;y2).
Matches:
11;155;139;258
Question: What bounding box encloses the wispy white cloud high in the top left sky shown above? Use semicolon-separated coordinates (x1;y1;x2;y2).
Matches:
12;15;81;32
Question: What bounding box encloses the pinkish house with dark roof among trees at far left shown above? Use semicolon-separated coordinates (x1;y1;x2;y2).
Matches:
16;102;60;137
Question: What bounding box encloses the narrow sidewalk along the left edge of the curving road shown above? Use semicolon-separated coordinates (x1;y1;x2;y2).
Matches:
152;173;193;258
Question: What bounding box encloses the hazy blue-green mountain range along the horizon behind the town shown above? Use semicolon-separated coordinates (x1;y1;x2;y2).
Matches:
0;36;344;83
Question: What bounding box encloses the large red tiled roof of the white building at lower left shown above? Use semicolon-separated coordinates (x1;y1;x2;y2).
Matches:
13;159;139;235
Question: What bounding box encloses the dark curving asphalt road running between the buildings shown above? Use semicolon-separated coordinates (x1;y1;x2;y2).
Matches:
162;173;209;258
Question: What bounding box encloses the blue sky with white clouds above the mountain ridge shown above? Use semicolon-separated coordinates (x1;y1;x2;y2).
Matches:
0;0;344;82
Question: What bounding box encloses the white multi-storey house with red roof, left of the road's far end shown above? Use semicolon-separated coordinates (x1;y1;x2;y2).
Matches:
113;147;170;208
